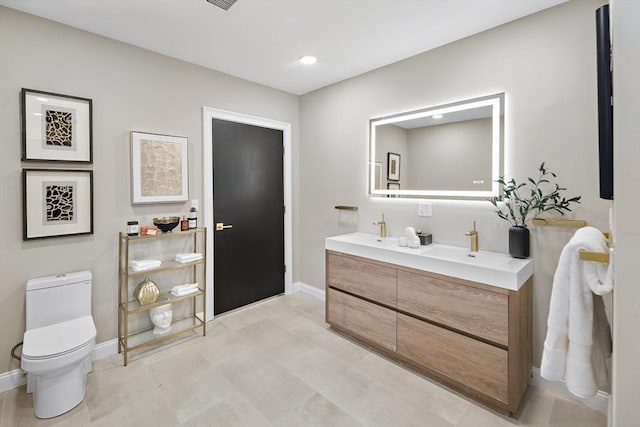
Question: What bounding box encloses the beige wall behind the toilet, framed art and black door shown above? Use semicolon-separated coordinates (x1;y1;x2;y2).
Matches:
0;7;299;372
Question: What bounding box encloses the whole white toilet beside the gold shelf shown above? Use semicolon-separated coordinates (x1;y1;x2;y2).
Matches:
21;271;96;418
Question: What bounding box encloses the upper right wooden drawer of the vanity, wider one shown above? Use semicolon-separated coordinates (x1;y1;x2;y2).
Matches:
398;270;509;346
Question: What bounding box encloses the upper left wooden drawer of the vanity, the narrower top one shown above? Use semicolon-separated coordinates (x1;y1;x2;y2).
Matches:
327;252;397;307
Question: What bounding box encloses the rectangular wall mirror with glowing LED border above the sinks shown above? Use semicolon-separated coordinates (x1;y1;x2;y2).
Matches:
368;93;505;198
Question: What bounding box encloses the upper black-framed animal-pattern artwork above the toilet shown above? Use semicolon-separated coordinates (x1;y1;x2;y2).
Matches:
20;88;93;163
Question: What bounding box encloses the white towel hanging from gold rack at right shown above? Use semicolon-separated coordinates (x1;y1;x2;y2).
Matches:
540;227;613;398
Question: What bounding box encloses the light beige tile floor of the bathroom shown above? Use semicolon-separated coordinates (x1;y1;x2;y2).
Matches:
0;293;607;427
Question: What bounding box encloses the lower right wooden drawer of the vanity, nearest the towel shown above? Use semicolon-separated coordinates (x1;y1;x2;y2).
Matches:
397;313;508;403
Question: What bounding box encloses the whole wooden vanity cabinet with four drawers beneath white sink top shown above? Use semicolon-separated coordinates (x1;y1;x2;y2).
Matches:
326;251;532;414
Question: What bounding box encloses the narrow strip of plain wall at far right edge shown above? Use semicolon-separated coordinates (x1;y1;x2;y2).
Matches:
611;0;640;427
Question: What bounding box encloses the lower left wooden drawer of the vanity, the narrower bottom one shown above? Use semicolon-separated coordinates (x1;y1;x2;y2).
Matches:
327;289;396;351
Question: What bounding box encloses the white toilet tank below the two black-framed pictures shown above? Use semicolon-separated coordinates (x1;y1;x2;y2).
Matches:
26;271;91;330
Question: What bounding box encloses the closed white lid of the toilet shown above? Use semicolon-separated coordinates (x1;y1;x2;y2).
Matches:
22;316;96;359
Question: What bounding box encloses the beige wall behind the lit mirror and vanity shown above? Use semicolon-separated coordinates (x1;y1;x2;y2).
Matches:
298;0;611;372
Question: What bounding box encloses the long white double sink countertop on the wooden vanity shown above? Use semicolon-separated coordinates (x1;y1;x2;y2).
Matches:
325;232;533;290
